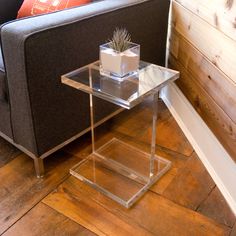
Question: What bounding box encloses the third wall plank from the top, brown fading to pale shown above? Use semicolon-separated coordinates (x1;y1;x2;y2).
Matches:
169;29;236;123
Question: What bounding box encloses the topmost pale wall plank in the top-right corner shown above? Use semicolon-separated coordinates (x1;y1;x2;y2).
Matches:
176;0;236;40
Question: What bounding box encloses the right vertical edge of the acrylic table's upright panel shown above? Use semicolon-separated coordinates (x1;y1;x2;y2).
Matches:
150;92;159;179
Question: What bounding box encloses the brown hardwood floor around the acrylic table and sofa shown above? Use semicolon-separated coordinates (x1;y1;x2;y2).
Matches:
0;102;236;236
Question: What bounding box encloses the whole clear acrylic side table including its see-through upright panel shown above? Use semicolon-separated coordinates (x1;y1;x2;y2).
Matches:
62;62;178;207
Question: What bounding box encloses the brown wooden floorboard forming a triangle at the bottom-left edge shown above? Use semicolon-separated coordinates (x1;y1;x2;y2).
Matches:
3;203;95;236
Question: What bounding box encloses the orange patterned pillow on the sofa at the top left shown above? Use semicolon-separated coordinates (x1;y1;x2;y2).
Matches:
17;0;91;18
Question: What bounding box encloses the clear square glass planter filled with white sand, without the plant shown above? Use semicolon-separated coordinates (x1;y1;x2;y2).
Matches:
100;43;140;81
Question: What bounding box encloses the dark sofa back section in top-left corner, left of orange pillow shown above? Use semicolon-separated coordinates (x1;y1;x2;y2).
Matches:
0;0;23;25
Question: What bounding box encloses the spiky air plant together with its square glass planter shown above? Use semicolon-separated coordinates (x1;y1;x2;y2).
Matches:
100;28;140;81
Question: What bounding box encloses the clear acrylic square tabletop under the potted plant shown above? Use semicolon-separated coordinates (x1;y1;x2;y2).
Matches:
62;61;179;109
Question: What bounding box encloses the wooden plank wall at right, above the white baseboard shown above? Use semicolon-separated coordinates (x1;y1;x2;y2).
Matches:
168;0;236;162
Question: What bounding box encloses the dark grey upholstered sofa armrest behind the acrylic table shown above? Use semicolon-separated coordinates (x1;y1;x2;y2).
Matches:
1;0;169;156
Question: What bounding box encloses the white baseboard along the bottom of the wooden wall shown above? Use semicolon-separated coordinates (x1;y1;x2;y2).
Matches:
160;83;236;215
